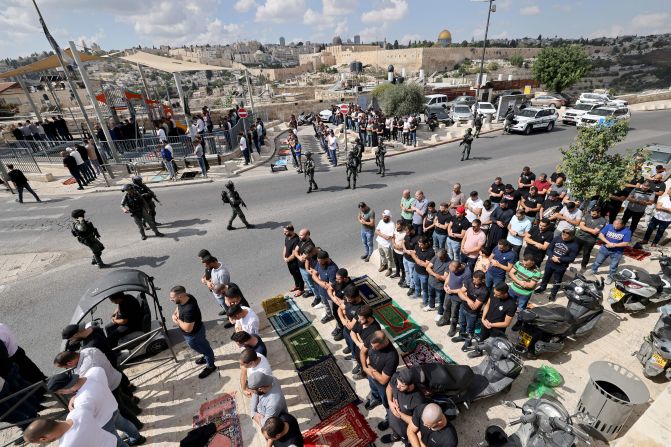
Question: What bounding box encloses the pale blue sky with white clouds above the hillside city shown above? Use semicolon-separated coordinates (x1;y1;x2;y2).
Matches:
0;0;671;59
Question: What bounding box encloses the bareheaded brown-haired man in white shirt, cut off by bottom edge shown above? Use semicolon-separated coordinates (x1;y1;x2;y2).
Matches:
23;408;117;447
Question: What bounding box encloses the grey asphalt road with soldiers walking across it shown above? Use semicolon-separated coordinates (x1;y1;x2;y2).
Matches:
5;112;671;371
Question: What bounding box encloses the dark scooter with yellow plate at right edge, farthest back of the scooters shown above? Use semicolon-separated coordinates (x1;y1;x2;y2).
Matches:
608;252;671;313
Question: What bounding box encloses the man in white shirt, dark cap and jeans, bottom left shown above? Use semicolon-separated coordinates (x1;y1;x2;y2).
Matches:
47;367;145;447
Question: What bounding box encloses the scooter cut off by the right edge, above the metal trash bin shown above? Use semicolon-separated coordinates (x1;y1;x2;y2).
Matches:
633;304;671;380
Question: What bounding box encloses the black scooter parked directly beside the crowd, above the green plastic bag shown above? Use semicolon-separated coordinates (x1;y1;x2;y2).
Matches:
515;268;604;357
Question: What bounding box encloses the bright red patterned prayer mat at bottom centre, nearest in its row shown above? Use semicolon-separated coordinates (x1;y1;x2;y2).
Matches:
303;404;377;447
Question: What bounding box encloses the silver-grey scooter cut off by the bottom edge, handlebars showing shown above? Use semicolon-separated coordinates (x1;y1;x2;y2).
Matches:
479;397;591;447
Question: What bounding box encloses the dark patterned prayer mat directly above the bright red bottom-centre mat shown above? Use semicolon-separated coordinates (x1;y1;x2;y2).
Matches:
298;356;359;420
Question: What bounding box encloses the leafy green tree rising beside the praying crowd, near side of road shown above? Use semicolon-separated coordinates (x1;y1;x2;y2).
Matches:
560;120;640;200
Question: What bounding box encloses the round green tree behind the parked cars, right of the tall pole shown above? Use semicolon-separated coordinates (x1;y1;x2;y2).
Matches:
531;45;590;92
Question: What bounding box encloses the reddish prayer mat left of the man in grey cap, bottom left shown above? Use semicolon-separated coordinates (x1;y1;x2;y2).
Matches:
193;393;242;447
